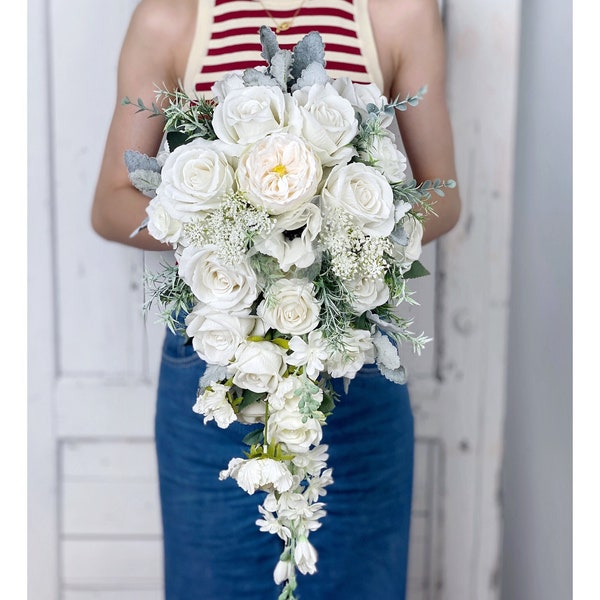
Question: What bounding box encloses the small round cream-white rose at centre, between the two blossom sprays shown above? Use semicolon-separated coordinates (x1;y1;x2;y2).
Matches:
256;279;321;335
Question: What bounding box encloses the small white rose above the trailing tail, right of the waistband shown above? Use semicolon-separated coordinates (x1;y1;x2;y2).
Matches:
229;341;286;393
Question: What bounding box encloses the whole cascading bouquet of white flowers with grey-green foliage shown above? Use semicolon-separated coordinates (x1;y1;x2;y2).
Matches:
123;26;454;600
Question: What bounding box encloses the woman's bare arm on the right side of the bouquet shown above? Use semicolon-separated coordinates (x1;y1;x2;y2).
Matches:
371;0;460;243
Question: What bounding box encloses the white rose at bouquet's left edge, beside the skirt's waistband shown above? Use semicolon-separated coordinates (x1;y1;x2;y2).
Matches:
185;304;256;365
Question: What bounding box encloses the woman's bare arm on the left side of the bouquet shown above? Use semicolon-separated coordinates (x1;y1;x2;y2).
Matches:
91;0;193;250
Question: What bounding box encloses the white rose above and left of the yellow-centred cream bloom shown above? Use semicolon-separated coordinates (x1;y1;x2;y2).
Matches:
212;85;298;146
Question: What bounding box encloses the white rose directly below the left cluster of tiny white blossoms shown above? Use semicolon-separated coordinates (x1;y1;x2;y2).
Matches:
178;246;258;311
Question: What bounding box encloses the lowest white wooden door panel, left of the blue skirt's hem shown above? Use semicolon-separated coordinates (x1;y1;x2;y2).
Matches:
61;538;162;590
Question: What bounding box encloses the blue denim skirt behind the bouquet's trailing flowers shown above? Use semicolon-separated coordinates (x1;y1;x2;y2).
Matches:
156;332;414;600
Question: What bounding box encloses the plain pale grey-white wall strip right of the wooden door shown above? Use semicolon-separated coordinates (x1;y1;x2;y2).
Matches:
502;0;572;600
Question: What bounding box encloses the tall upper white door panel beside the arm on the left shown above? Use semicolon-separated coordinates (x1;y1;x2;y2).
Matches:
50;0;145;374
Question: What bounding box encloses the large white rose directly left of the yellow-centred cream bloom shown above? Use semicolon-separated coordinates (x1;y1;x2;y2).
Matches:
156;138;234;219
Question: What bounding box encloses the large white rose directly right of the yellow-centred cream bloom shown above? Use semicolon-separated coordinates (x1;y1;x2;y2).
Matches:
321;163;394;237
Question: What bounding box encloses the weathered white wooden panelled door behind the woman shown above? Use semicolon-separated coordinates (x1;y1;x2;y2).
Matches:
29;0;519;600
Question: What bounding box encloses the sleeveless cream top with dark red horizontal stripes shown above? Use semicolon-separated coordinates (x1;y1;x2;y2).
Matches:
184;0;383;97
